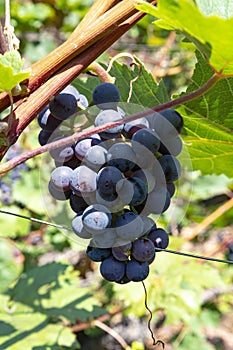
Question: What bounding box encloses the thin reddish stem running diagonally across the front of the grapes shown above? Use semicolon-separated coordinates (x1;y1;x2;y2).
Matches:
0;73;222;177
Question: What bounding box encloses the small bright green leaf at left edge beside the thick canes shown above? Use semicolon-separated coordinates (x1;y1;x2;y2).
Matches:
0;51;30;92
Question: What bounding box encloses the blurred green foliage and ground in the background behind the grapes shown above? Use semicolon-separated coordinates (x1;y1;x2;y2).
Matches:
0;0;233;350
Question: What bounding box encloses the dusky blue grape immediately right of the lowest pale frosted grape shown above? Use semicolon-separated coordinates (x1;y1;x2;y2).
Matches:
115;211;144;241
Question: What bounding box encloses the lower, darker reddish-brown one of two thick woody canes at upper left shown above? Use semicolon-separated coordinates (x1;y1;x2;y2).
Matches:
0;1;157;159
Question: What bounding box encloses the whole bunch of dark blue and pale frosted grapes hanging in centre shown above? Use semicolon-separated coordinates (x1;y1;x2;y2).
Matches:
38;83;183;284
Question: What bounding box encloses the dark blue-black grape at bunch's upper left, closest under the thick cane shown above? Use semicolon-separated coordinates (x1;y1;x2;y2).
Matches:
49;93;77;120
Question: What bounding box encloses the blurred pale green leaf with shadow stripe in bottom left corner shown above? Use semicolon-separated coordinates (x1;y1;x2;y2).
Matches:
0;303;80;350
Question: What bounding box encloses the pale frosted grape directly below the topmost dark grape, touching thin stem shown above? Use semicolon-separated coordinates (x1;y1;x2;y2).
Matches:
94;109;123;136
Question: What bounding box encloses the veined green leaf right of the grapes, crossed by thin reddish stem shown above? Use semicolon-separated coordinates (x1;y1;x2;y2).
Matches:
178;53;233;178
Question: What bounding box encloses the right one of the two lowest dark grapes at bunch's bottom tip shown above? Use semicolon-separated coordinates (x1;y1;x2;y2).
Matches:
126;259;149;282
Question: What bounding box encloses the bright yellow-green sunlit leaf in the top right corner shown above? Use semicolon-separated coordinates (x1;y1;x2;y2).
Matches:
136;0;233;75
